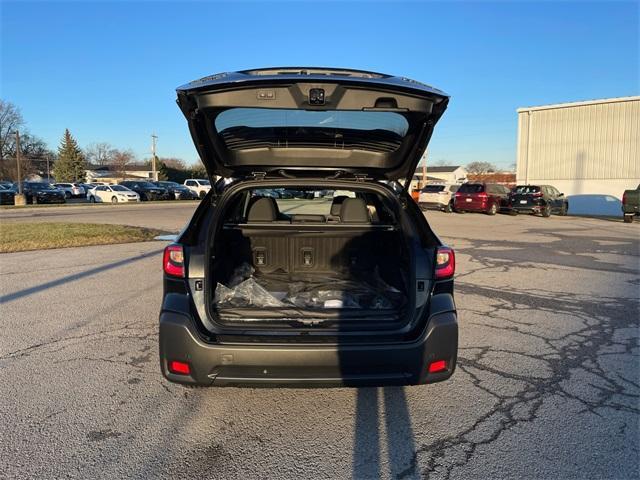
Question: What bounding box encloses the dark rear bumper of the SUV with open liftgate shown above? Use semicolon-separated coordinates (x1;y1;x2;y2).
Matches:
159;312;458;386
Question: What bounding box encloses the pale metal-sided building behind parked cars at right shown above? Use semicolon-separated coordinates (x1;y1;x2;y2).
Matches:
516;97;640;214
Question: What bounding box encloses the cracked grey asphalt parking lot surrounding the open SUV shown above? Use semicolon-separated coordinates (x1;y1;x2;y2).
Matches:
0;202;640;479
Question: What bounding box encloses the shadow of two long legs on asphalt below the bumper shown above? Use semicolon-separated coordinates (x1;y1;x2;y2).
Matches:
351;387;416;479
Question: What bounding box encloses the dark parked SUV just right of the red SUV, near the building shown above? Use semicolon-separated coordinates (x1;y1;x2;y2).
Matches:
509;185;569;217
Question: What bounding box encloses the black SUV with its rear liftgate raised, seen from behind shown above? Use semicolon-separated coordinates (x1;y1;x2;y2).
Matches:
159;68;458;386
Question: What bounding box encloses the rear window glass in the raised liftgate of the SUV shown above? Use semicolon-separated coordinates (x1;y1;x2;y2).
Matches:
215;108;409;152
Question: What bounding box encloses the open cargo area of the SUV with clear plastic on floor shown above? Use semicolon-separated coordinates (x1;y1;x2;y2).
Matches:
208;192;410;324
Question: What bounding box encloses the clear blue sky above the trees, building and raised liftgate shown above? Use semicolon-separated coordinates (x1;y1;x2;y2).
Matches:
0;1;640;167
